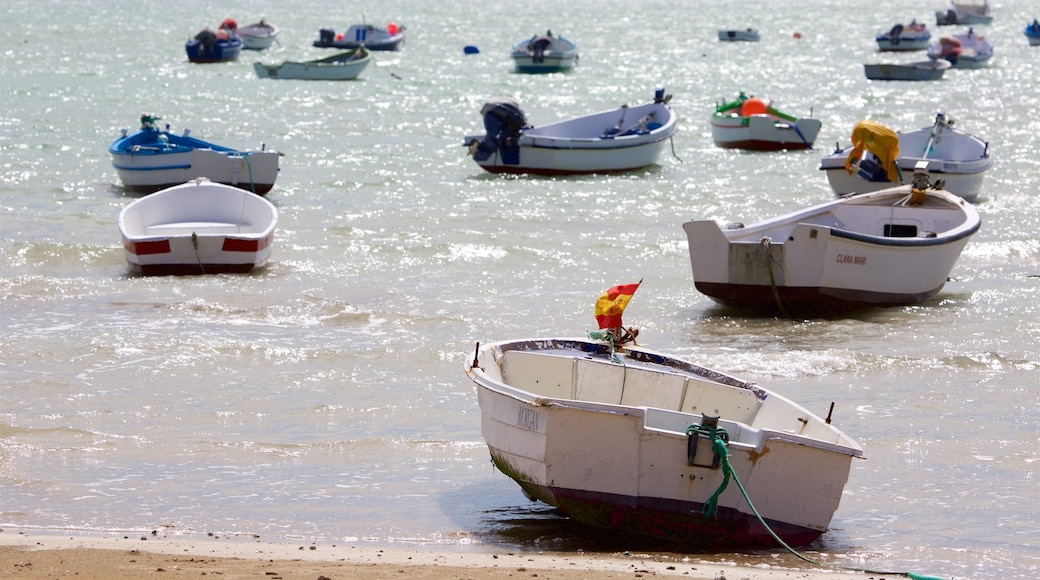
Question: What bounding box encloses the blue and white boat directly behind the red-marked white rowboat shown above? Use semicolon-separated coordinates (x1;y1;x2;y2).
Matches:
108;114;281;195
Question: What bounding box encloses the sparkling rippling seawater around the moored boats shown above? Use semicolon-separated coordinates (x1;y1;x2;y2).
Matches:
0;0;1040;578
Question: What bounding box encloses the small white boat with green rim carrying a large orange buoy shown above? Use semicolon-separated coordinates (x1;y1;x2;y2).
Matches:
710;91;823;151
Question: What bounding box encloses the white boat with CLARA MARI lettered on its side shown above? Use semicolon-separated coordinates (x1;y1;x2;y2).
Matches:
683;172;980;316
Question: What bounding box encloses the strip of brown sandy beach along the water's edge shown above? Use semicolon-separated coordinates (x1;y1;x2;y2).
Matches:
0;529;877;580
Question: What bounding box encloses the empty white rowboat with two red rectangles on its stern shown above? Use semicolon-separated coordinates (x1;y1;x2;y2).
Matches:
119;179;278;275
